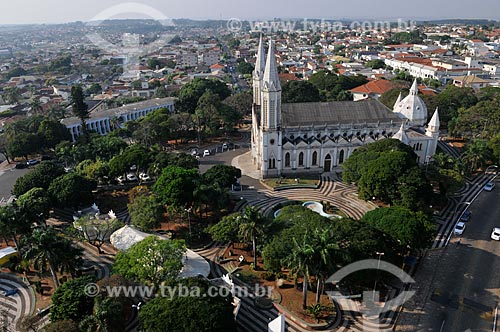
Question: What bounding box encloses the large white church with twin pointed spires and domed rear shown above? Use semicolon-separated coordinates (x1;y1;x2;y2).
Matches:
251;36;439;178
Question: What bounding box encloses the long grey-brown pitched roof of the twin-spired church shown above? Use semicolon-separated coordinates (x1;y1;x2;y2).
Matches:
281;99;401;127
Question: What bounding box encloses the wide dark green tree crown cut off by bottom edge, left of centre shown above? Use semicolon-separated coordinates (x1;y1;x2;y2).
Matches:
139;278;237;332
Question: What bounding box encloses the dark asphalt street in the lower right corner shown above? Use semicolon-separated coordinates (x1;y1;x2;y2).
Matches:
403;183;500;332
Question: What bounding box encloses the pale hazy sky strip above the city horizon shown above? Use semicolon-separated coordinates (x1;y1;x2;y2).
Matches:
0;0;500;24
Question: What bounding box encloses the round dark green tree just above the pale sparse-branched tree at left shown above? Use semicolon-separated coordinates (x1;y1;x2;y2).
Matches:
48;173;96;209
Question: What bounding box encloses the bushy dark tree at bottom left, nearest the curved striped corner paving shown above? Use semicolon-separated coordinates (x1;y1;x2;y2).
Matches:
50;276;94;322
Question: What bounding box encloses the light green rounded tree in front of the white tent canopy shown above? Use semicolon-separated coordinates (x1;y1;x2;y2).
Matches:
113;236;186;287
